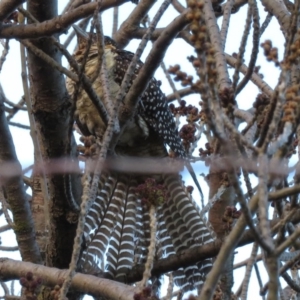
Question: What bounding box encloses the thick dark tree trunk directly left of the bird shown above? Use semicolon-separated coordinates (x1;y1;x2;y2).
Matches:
28;1;79;268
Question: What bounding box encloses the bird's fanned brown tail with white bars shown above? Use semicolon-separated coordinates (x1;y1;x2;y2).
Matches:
81;174;212;291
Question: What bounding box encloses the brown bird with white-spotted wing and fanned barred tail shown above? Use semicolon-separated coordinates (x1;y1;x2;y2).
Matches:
66;26;213;291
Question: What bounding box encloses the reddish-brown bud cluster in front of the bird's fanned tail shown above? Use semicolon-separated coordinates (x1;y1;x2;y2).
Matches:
135;178;169;206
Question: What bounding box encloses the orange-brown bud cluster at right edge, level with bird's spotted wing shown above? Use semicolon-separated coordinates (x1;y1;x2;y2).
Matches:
282;85;300;125
